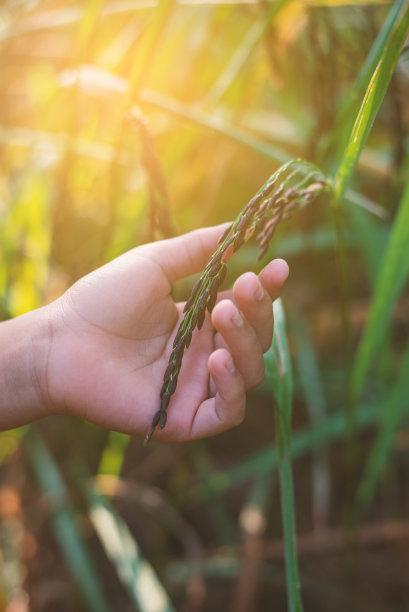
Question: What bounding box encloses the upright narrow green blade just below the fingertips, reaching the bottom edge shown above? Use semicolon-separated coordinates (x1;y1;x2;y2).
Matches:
271;300;303;612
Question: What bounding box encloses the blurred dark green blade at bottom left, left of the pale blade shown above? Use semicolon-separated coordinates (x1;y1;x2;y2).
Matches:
24;426;110;612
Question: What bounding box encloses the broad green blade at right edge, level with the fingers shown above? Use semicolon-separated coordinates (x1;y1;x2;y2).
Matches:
350;175;409;399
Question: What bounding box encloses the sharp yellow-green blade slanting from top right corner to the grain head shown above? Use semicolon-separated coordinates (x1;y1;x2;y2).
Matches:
334;6;409;203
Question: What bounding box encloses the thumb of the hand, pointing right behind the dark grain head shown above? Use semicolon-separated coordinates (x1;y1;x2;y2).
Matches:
140;223;229;283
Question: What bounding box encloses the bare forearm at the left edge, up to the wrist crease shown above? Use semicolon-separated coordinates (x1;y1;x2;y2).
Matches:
0;309;48;430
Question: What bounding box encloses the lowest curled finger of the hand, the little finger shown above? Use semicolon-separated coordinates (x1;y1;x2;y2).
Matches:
190;349;246;439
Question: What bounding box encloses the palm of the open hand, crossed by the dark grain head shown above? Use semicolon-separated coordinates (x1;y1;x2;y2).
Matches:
46;246;213;437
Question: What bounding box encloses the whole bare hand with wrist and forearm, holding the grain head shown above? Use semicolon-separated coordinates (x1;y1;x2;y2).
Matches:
0;226;288;441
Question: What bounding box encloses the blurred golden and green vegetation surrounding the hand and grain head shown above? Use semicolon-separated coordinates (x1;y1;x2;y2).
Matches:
0;0;409;612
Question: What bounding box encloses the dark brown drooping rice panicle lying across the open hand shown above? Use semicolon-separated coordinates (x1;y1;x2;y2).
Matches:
145;159;329;444
